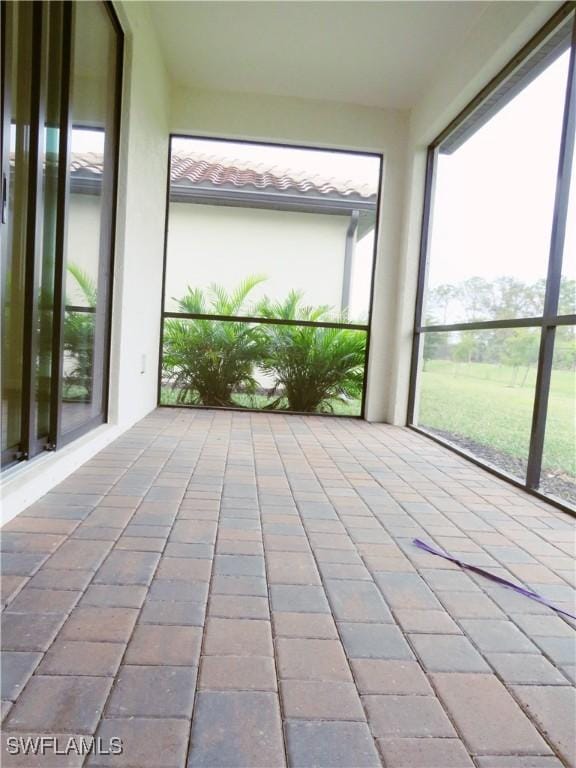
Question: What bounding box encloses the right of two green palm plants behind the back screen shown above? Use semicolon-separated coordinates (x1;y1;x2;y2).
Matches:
258;291;366;411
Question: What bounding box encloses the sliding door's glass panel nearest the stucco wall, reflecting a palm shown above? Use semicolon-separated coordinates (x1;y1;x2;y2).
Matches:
61;2;118;436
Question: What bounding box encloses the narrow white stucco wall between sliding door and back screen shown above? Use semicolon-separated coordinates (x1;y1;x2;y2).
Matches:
110;2;170;425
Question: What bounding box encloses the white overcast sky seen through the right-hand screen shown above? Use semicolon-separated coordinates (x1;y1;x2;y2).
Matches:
429;51;576;294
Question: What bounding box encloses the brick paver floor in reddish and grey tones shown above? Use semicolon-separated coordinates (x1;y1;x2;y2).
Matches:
2;409;576;768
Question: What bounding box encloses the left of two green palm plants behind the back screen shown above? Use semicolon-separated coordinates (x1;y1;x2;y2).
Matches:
163;275;266;406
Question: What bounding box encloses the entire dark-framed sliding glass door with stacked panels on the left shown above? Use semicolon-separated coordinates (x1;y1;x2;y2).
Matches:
1;1;122;468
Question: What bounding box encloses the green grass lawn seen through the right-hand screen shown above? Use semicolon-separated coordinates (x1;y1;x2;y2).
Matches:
419;360;576;477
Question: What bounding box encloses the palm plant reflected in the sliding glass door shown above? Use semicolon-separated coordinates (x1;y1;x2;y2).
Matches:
63;264;97;401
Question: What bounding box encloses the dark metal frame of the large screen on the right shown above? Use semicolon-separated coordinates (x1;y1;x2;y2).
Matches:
406;2;576;515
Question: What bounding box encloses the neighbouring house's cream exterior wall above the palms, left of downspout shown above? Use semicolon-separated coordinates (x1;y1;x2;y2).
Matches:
166;203;349;310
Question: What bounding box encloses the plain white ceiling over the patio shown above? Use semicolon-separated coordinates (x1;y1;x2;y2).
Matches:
149;0;500;109
